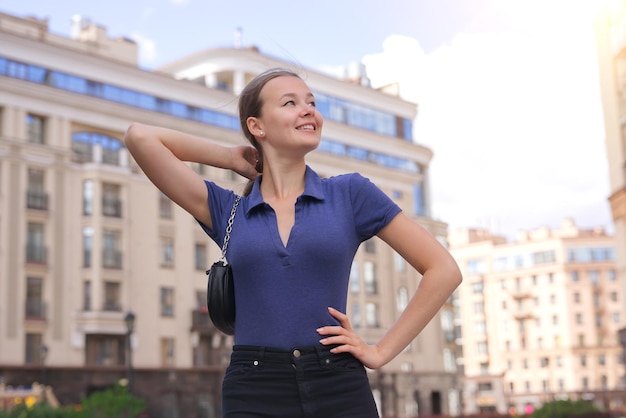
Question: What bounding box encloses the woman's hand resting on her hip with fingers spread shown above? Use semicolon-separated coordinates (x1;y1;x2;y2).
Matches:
317;307;386;369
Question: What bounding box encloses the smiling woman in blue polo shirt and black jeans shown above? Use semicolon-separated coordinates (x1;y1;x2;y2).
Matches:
125;69;461;418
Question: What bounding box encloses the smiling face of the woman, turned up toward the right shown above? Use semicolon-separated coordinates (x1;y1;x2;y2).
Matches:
257;76;324;153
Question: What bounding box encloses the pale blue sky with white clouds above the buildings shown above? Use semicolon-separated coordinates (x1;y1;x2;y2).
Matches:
0;0;613;238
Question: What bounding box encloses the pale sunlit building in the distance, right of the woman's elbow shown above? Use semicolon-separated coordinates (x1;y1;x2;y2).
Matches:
449;219;624;414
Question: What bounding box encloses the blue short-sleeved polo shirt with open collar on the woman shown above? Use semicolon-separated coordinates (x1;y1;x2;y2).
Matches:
201;167;401;349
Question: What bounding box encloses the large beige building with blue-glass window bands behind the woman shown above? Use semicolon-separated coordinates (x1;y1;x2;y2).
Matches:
0;14;460;417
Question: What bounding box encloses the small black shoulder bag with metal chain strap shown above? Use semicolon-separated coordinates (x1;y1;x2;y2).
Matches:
206;196;241;335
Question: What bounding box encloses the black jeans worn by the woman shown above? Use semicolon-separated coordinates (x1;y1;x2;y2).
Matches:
222;345;378;418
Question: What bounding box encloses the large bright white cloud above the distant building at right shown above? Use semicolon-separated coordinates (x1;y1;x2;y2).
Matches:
363;2;610;240
